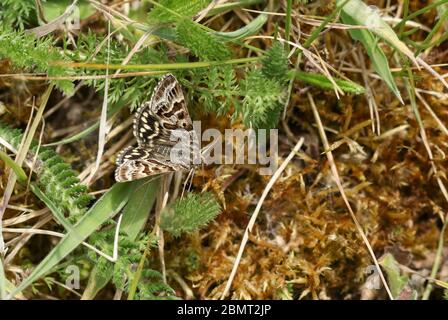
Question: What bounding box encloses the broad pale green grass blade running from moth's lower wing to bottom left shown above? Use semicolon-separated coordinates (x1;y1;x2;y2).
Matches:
11;183;134;296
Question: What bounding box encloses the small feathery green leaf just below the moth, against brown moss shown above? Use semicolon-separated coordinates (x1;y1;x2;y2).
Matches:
160;192;221;237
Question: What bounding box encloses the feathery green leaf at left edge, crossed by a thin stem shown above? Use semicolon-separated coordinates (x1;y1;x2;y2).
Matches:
0;122;93;221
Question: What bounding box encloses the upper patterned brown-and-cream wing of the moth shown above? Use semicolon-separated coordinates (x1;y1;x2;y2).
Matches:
134;74;193;146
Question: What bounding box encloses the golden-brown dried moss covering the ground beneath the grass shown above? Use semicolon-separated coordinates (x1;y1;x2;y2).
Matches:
0;1;448;299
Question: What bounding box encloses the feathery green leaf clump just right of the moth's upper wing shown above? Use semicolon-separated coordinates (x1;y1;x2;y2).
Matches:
189;41;288;128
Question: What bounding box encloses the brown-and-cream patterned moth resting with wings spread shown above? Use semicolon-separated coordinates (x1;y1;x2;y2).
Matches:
115;74;197;182
